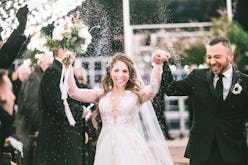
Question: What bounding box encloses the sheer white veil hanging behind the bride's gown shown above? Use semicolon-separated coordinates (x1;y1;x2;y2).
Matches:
136;63;174;165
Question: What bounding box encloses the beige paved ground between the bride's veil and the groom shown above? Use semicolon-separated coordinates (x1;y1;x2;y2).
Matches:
167;138;189;165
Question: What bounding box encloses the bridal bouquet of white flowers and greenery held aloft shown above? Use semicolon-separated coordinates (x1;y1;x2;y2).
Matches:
46;16;92;64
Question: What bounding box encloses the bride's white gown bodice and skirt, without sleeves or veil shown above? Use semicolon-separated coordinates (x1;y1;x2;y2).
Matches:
94;91;157;165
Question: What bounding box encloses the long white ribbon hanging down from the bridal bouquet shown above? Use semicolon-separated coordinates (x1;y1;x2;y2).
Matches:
59;65;76;126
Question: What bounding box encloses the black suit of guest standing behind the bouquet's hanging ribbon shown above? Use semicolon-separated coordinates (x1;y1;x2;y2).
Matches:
36;60;84;165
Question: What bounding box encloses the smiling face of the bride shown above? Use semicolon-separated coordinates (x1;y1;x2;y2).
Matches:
110;61;129;87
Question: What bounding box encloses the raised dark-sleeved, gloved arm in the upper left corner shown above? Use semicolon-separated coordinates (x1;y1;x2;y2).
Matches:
0;5;29;69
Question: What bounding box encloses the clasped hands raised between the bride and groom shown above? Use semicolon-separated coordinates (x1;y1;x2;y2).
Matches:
152;49;171;64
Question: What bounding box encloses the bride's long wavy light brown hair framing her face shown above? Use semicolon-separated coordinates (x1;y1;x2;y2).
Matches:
92;52;141;129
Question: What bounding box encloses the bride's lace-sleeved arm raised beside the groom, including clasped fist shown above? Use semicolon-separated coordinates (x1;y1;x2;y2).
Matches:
141;49;170;102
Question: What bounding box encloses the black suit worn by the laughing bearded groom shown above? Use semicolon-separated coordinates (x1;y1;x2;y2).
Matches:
161;63;248;163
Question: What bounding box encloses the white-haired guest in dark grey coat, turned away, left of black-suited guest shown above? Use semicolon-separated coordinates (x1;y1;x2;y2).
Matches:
16;54;53;165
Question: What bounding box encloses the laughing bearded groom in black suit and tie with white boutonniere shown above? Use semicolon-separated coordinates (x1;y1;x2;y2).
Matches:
161;37;248;165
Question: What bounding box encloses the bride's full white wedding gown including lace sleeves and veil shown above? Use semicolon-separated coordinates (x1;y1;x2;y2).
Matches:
68;65;173;165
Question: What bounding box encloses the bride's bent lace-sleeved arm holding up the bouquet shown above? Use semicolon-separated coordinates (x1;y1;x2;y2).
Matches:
68;65;101;102
